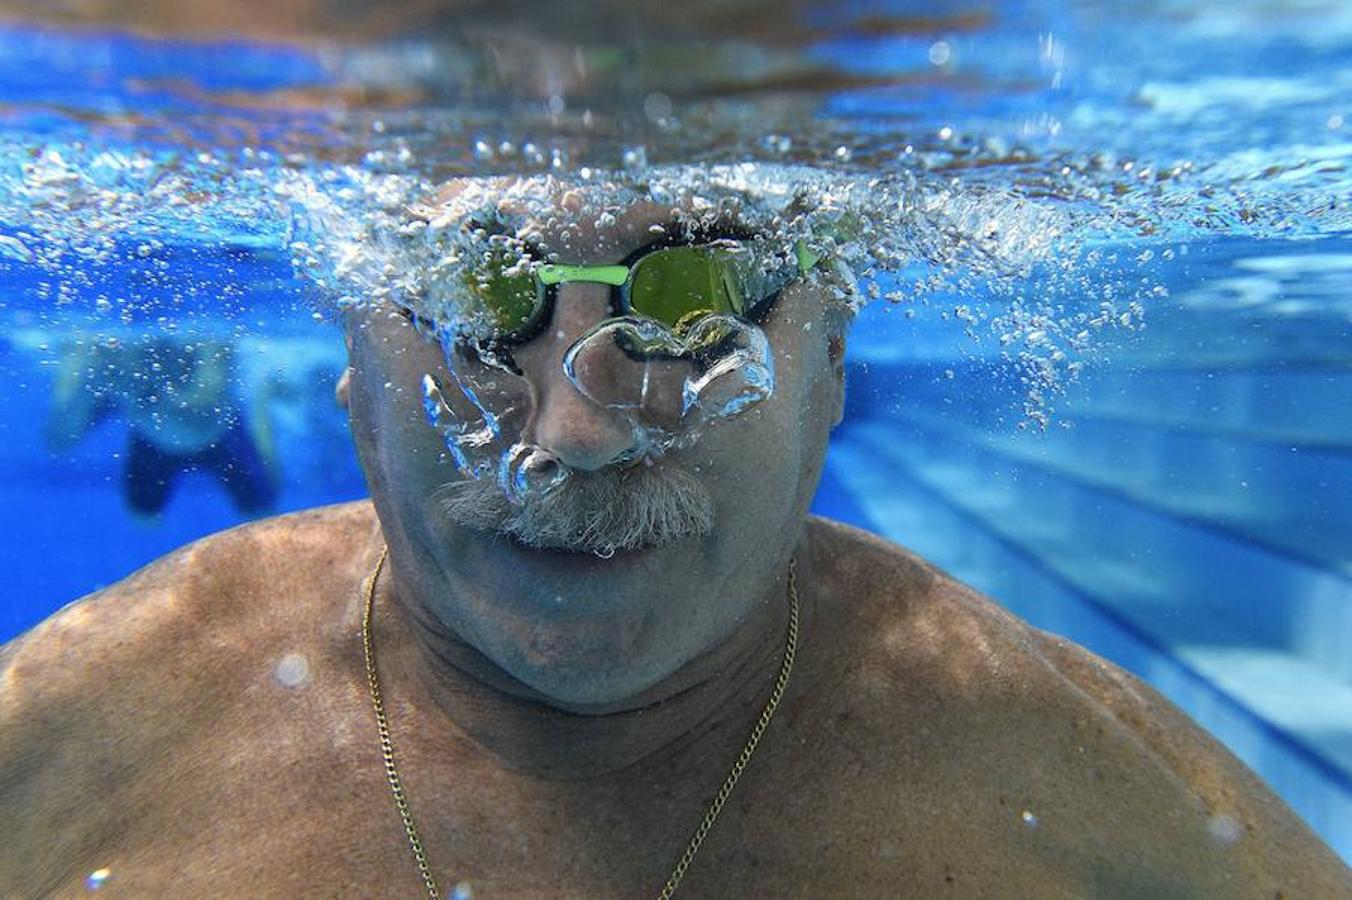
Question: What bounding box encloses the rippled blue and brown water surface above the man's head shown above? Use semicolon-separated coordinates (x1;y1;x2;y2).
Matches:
0;4;1352;397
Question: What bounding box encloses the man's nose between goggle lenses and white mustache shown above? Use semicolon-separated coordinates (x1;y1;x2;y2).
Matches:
514;284;635;472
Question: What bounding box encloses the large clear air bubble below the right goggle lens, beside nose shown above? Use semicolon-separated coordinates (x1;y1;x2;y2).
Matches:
564;315;775;449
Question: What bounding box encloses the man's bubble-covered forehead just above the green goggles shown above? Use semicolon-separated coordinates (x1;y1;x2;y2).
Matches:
412;177;754;264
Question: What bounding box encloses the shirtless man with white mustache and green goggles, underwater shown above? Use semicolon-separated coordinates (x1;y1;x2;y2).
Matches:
0;170;1352;899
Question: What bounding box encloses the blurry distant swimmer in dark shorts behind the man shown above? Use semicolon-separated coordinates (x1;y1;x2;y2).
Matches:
46;336;277;516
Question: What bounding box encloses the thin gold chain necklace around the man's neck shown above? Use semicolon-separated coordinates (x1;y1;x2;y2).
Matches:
361;545;798;900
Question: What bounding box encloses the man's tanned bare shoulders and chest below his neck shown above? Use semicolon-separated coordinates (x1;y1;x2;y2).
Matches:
0;503;1352;899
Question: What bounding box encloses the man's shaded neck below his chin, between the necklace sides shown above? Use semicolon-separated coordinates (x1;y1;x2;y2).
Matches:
372;535;810;780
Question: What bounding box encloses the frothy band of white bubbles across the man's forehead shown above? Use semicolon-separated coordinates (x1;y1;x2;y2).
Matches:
288;161;1068;312
